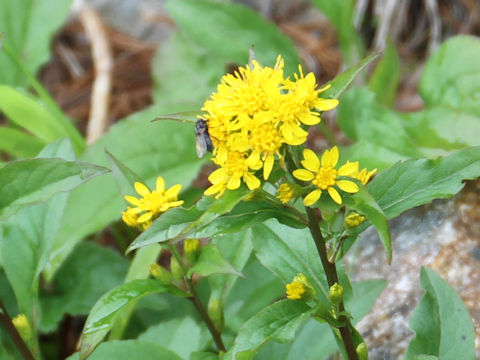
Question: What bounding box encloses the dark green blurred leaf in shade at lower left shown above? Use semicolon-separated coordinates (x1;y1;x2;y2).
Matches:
40;242;128;332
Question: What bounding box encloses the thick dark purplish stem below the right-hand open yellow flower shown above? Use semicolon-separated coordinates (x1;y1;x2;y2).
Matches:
305;206;358;360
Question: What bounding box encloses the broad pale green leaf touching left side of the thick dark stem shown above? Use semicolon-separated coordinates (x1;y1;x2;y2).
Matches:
252;220;329;304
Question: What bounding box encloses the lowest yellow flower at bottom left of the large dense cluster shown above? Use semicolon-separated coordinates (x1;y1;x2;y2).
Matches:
204;152;261;199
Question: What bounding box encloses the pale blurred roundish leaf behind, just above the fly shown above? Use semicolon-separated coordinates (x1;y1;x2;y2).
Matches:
152;31;225;104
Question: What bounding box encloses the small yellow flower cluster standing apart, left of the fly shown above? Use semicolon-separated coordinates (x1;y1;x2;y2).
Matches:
122;176;183;230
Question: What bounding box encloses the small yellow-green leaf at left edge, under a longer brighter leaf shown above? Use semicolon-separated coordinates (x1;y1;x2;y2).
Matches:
0;126;45;158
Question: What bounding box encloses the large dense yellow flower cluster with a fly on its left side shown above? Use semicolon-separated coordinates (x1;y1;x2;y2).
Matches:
202;56;338;198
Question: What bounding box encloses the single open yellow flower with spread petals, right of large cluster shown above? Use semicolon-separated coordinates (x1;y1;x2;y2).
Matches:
293;146;359;206
